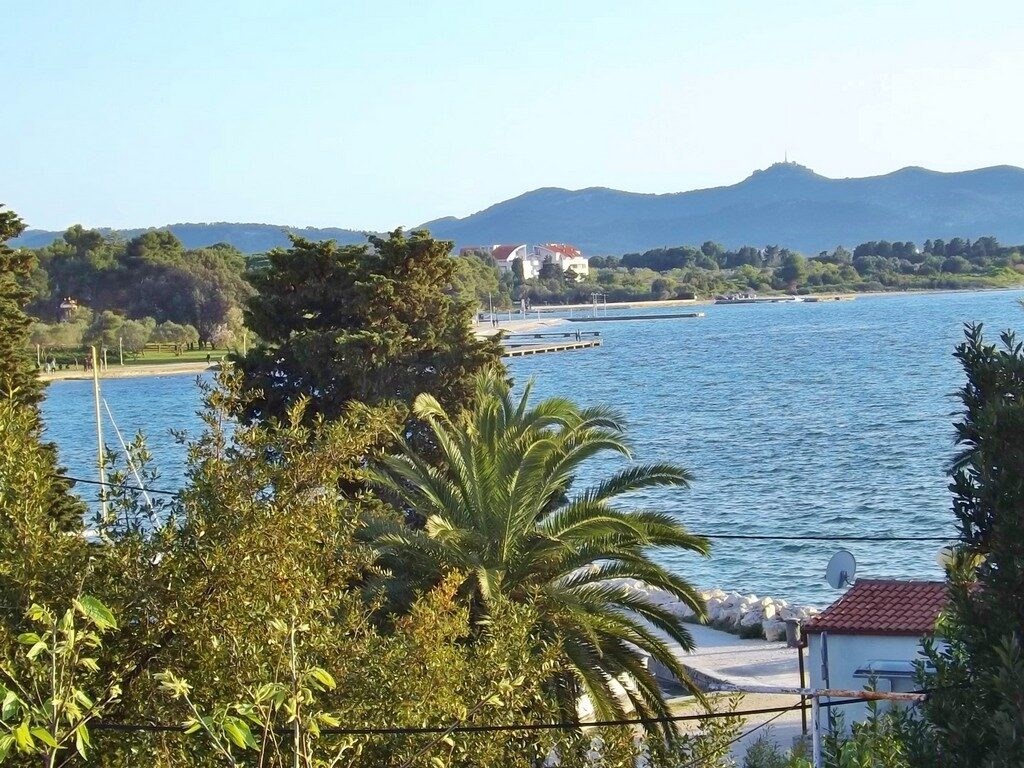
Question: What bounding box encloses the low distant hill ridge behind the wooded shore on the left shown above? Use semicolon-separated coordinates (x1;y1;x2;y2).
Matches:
12;222;367;253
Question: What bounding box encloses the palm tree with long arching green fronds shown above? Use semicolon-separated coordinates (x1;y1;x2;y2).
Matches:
367;375;708;737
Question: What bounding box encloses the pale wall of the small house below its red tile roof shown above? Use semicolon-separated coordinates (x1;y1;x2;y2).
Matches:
806;633;922;724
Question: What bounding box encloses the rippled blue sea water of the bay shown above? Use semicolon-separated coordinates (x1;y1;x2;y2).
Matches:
43;291;1024;604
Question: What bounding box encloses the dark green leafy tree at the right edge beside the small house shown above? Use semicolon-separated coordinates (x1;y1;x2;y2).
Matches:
926;325;1024;768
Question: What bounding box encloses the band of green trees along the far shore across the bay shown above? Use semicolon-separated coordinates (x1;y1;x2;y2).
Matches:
17;219;1024;372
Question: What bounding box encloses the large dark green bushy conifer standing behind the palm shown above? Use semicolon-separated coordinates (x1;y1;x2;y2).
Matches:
238;230;500;430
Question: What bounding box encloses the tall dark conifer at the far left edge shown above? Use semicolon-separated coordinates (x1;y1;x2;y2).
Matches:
0;201;84;530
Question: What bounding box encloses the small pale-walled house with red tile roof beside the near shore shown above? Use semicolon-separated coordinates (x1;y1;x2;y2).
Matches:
803;579;946;723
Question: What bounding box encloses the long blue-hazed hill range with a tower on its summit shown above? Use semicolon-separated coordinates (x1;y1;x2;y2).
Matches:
424;163;1024;255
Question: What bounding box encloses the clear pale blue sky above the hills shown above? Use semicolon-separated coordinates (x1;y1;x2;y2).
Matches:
0;0;1024;229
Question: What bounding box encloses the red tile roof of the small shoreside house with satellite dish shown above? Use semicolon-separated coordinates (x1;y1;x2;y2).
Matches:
804;579;946;635
